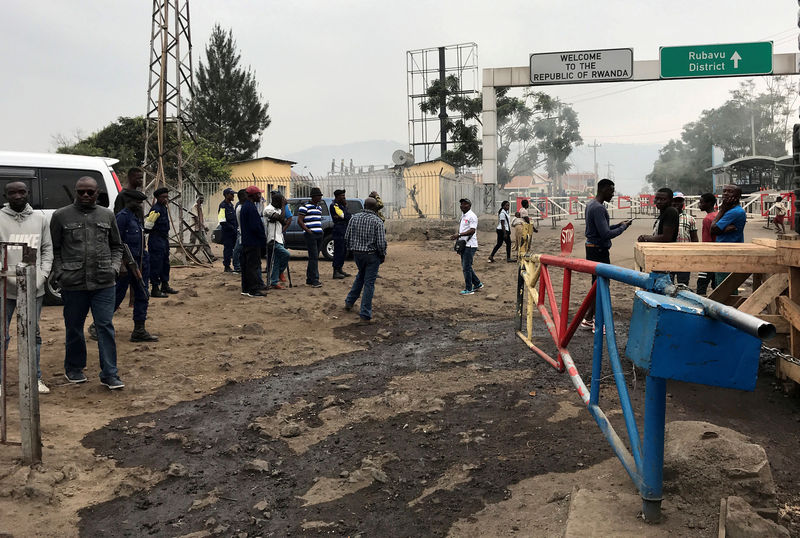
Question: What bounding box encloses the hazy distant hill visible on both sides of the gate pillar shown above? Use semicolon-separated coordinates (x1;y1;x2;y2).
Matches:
280;140;661;194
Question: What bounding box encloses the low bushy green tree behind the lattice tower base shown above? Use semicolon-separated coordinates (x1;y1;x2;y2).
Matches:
56;116;231;182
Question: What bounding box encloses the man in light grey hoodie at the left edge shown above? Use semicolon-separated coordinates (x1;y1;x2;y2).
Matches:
0;181;53;394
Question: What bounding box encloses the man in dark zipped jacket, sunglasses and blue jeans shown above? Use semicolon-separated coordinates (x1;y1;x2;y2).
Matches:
50;176;125;390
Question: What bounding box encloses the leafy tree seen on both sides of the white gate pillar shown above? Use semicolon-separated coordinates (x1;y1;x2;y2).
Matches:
420;75;583;185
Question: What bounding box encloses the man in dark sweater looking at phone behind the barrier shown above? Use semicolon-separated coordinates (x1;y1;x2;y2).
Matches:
581;179;633;331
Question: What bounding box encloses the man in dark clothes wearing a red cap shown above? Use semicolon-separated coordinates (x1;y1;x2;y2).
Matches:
239;185;267;297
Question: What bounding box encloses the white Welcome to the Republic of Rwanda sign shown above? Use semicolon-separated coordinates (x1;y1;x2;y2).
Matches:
530;49;633;86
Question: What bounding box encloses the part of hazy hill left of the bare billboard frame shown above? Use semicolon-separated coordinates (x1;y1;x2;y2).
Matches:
282;140;408;176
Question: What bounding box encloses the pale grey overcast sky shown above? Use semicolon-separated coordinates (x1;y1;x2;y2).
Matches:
0;0;798;171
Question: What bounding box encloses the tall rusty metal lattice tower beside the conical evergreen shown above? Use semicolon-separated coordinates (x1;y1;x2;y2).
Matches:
143;0;210;263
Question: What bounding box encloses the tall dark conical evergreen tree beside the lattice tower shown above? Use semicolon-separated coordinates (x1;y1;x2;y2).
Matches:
191;24;272;162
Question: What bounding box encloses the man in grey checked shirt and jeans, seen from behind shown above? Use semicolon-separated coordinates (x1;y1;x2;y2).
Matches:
344;198;386;323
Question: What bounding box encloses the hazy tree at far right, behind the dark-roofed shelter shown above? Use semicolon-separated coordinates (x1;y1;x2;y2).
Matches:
647;77;798;194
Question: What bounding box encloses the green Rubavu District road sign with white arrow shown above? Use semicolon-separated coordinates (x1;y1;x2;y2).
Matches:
660;41;772;78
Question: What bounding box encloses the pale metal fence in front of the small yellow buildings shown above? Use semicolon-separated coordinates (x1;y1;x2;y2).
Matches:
188;169;500;222
